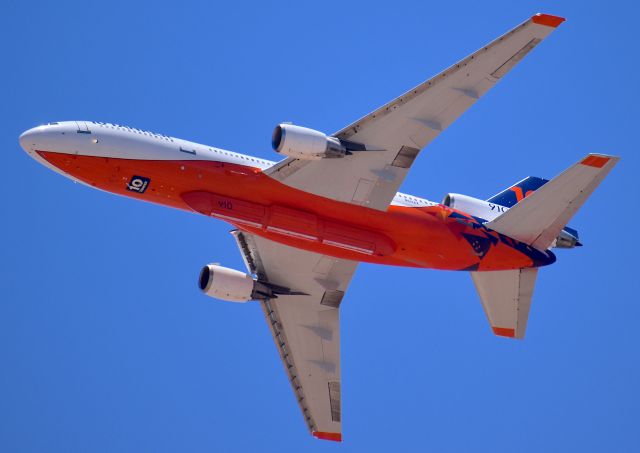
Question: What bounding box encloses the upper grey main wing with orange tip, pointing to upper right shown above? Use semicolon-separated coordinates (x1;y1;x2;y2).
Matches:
266;14;564;211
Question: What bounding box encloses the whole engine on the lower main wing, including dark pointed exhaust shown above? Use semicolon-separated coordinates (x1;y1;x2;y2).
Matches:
198;264;304;302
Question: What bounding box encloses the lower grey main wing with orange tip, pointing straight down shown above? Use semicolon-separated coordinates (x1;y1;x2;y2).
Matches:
232;230;358;441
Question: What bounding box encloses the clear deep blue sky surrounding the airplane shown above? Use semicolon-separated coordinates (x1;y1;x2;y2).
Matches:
0;0;640;452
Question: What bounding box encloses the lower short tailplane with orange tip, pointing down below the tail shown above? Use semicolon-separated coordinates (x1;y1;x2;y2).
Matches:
471;268;538;338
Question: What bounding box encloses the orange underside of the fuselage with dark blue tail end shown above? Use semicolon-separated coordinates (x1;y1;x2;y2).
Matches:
39;151;555;270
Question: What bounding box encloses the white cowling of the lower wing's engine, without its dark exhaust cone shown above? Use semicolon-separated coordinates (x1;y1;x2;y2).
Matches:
198;264;257;302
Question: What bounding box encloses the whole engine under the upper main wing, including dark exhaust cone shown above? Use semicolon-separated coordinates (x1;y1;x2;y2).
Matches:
271;124;366;160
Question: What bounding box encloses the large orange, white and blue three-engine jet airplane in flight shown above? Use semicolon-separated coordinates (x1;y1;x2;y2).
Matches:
19;14;619;441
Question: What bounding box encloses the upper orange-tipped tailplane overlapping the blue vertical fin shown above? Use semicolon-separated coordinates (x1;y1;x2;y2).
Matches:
485;154;620;250
